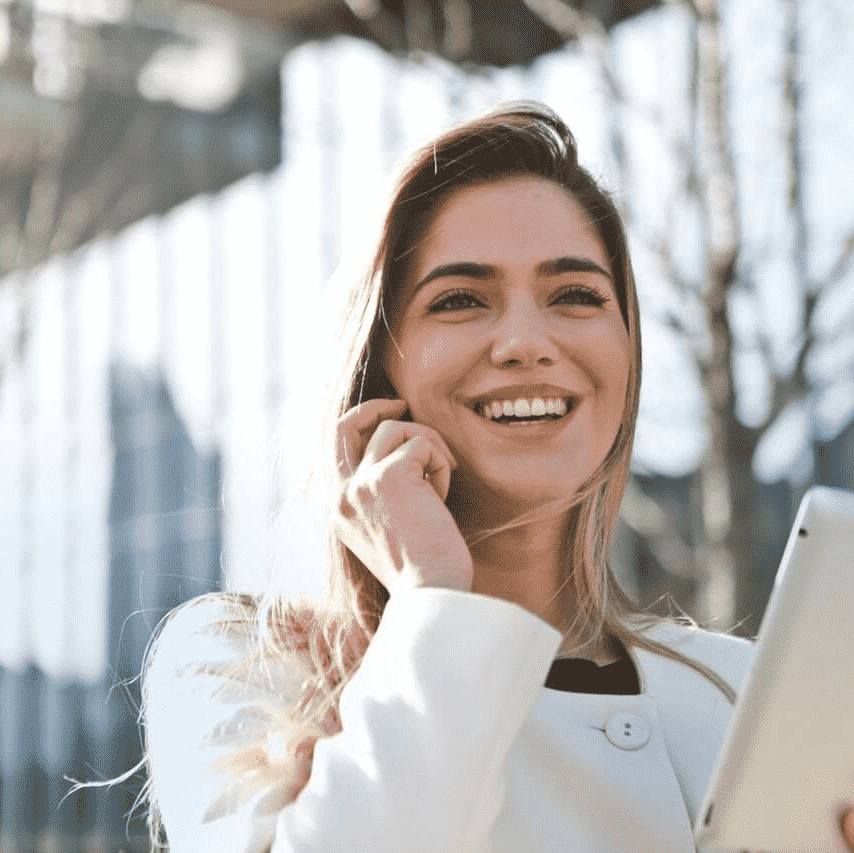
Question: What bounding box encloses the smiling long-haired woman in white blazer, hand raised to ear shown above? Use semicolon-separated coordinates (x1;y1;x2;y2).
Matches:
137;106;852;853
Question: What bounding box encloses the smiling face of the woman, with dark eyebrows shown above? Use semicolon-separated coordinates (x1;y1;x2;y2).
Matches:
385;176;631;514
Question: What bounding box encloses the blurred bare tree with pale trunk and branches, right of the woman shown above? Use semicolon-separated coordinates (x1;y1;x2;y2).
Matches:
526;0;854;633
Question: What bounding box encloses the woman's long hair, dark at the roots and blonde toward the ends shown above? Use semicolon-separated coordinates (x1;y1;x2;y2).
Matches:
83;103;735;847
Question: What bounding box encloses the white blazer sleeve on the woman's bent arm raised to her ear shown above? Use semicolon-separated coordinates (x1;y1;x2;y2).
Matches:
146;588;561;853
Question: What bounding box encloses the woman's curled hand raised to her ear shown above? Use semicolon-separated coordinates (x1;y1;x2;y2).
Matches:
333;400;473;595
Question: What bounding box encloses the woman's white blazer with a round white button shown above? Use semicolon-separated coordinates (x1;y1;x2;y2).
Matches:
145;589;753;853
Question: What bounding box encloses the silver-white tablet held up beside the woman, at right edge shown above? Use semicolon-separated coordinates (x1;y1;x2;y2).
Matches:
694;487;854;853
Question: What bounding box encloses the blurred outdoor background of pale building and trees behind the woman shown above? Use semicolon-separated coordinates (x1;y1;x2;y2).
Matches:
0;0;854;853
